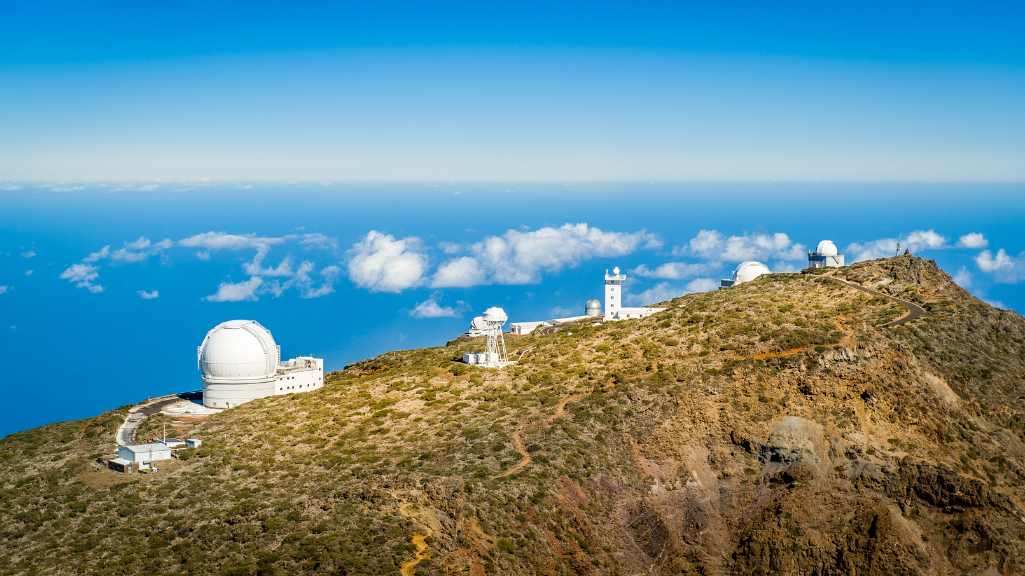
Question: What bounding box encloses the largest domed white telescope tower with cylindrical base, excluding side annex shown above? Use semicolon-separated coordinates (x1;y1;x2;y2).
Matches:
197;320;281;408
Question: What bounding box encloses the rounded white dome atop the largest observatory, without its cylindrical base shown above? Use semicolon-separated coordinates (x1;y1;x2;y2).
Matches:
199;320;279;383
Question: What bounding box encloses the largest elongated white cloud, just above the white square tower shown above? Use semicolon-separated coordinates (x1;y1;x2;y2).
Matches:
432;222;661;287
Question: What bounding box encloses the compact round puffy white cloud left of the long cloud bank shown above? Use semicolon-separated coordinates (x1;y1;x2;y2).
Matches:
349;230;427;292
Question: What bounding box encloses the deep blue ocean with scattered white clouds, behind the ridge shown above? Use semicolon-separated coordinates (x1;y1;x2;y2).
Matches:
0;183;1025;435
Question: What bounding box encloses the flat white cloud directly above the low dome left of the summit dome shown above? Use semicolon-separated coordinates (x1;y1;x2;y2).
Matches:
672;230;808;262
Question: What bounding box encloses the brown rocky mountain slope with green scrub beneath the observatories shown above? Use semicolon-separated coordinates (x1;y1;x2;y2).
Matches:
0;256;1025;575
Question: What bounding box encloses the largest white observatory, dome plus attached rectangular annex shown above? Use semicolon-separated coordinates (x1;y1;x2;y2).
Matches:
197;320;324;408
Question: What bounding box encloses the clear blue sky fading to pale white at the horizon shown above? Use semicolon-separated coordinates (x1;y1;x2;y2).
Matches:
0;2;1025;181
